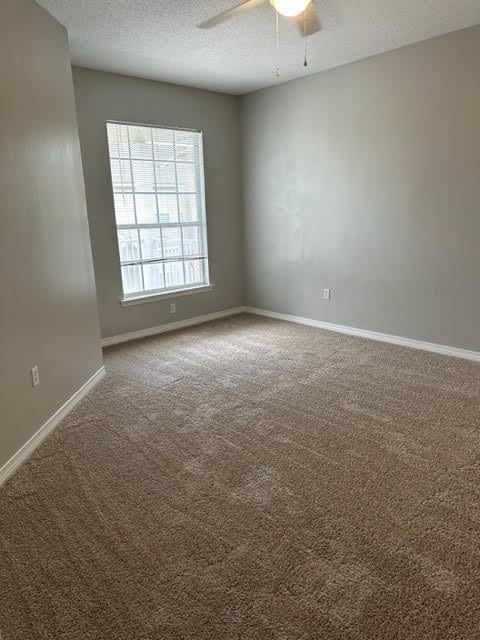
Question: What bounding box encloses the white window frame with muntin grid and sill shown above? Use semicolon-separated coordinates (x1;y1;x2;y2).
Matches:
105;119;214;306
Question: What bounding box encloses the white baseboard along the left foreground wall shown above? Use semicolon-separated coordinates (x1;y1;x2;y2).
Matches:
0;367;105;487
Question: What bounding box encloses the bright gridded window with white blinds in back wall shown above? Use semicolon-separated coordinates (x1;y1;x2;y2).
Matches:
107;122;209;299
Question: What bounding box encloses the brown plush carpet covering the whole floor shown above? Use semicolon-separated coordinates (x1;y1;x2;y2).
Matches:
0;315;480;640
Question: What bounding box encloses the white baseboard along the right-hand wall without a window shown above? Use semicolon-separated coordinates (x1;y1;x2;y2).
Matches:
245;307;480;362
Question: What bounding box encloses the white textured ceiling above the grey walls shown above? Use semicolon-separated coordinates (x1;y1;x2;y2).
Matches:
37;0;480;94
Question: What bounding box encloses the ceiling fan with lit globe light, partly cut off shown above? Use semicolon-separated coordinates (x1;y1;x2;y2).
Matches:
198;0;322;36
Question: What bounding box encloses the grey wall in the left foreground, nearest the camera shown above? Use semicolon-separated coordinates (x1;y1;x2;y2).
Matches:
0;0;102;466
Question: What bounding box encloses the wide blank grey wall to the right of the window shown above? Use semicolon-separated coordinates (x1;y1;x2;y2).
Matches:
243;27;480;350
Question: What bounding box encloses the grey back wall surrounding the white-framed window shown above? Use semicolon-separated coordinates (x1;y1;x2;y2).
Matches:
74;68;243;337
